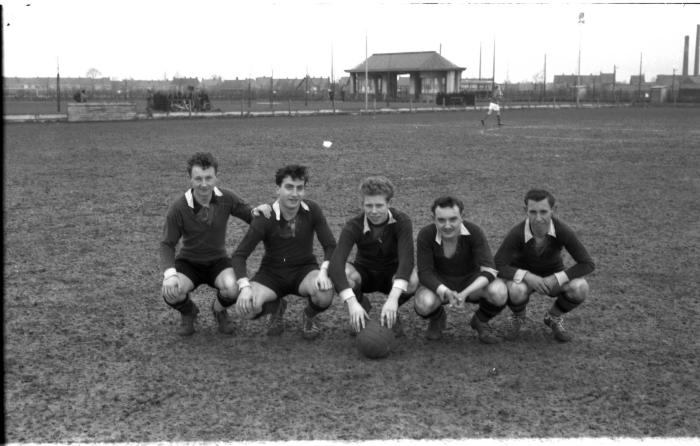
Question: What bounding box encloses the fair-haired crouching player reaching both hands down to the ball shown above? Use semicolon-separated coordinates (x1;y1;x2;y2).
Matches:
329;176;418;336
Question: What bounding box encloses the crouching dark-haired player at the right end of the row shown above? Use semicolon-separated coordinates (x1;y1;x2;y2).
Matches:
495;189;595;342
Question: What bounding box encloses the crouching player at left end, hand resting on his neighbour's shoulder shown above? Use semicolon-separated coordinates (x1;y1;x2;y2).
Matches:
160;152;270;336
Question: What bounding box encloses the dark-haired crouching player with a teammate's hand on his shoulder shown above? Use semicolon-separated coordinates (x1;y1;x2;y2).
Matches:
232;164;335;340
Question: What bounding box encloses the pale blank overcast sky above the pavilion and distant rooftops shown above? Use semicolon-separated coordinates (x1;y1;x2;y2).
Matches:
0;0;700;82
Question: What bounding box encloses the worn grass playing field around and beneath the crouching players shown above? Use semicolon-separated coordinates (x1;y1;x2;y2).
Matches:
3;108;700;442
